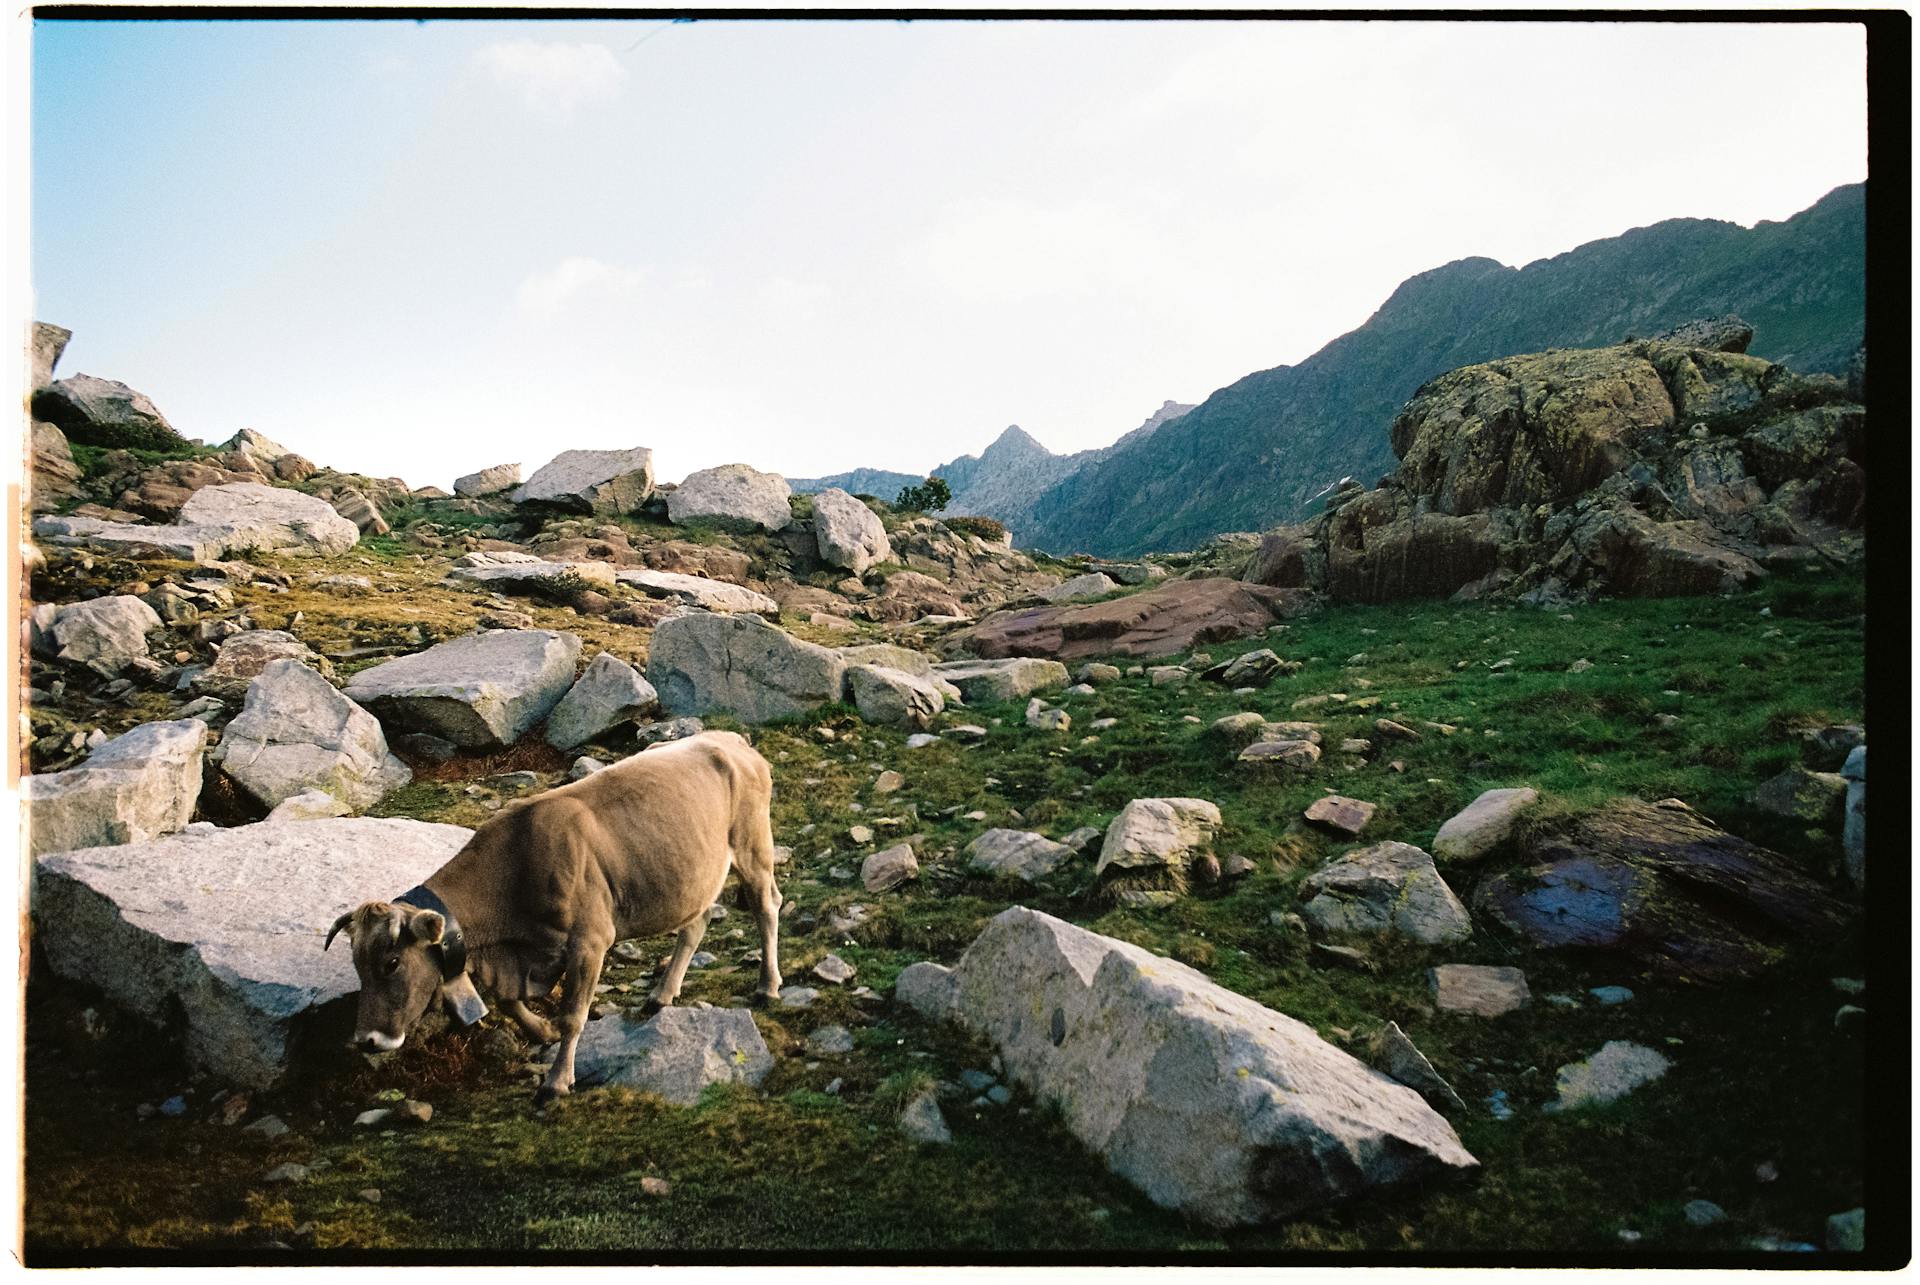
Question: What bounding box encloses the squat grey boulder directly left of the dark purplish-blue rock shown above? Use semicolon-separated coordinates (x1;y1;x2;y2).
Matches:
1300;843;1473;945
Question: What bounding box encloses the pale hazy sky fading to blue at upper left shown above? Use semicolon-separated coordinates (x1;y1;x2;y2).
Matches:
33;21;1866;486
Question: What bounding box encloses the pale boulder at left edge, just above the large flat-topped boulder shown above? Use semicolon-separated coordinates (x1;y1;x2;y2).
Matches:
21;718;207;857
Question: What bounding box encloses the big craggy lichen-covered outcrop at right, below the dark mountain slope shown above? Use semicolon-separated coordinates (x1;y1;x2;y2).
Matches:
1246;319;1864;603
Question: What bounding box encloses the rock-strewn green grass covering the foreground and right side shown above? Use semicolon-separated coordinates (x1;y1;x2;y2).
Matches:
27;572;1864;1260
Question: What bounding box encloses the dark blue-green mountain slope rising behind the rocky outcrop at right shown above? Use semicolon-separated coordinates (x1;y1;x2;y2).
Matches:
1029;184;1866;555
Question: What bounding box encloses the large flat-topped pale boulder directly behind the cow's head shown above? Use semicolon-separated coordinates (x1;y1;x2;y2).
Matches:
33;816;472;1089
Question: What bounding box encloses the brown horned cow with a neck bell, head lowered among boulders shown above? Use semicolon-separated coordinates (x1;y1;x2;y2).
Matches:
326;732;781;1099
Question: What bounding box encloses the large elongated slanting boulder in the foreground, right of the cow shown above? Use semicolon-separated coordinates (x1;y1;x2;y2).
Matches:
900;907;1478;1227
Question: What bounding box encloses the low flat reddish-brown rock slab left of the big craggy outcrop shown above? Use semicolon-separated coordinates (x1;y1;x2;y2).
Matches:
947;578;1311;661
